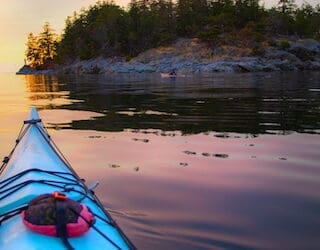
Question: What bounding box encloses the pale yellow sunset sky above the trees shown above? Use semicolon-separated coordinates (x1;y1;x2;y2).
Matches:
0;0;320;69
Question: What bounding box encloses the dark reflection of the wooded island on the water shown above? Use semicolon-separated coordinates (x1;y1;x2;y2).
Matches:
26;72;320;134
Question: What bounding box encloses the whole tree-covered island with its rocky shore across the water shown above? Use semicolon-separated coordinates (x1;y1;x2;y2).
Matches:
17;0;320;74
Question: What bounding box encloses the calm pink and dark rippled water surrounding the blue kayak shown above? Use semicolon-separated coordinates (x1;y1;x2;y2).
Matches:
0;72;320;249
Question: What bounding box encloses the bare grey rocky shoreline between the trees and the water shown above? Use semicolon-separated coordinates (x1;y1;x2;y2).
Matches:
17;39;320;74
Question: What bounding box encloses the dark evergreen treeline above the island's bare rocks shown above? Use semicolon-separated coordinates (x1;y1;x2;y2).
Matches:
27;0;320;66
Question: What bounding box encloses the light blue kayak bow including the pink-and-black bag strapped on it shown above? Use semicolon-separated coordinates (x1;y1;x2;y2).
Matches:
0;108;135;250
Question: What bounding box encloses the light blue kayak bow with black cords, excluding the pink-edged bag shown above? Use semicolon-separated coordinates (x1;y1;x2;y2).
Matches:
0;108;135;250
